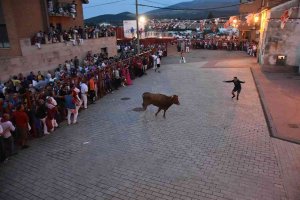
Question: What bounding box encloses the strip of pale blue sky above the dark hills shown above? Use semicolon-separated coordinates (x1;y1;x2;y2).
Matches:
83;0;192;19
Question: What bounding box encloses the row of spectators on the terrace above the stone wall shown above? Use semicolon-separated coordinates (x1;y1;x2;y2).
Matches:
31;25;115;48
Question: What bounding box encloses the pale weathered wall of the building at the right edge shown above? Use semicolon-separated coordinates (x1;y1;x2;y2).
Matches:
259;0;300;66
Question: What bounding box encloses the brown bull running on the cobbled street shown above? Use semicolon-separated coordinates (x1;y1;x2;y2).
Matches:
142;92;180;118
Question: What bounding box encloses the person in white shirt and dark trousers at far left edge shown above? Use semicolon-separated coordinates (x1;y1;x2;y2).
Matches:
0;114;16;159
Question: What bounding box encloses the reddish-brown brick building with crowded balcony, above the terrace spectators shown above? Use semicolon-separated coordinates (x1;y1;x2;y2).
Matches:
0;0;86;56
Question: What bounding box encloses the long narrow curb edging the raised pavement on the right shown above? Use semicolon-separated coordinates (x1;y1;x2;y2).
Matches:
250;67;300;145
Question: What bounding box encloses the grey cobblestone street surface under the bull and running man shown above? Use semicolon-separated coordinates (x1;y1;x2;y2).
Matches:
0;58;287;200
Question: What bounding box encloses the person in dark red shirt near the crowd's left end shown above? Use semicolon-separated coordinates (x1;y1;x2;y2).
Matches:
12;104;29;149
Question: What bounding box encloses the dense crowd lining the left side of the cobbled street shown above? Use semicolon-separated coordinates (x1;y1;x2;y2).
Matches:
0;45;166;162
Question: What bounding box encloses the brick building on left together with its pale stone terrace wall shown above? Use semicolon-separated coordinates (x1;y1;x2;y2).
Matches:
0;0;117;80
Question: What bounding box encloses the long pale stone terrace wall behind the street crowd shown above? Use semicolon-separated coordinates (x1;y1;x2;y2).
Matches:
0;37;117;80
